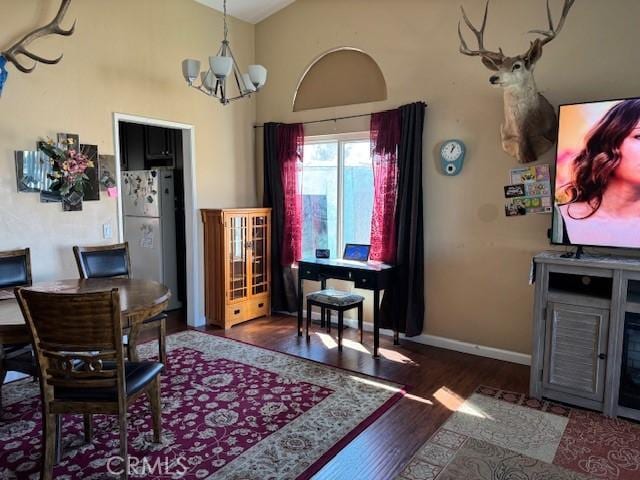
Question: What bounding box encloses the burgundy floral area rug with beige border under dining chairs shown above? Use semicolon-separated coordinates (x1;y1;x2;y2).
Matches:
0;331;403;480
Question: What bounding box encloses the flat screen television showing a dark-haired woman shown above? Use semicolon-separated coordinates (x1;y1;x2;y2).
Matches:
551;98;640;248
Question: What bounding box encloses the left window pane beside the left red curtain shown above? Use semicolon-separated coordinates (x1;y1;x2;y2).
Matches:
302;141;338;258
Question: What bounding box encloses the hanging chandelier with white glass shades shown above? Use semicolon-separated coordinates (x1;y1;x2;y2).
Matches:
182;0;267;105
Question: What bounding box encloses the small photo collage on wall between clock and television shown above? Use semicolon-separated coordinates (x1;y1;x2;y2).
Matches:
504;165;552;217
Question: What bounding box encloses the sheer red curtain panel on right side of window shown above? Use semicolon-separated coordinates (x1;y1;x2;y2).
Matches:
370;109;400;263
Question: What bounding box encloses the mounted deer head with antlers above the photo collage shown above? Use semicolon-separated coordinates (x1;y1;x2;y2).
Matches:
458;0;575;163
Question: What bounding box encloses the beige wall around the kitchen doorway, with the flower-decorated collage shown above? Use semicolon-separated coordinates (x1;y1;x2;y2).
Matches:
0;0;257;320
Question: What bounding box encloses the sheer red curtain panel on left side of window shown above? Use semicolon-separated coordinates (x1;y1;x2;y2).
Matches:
278;123;304;266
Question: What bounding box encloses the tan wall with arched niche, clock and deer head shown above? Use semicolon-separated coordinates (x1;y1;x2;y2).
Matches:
256;0;640;353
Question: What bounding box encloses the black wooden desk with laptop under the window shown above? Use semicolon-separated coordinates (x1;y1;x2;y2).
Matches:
298;258;400;358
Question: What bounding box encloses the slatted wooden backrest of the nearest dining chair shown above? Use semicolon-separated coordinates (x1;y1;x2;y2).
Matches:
16;288;124;394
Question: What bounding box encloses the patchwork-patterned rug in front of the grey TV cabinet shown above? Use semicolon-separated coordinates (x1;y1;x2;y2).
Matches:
398;387;640;480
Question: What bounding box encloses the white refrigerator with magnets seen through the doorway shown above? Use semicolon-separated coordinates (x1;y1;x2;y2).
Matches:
121;169;182;310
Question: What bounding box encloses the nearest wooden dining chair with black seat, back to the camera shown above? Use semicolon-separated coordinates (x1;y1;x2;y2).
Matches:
16;288;162;480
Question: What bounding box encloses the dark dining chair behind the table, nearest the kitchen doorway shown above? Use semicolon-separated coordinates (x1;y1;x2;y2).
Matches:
73;242;167;365
